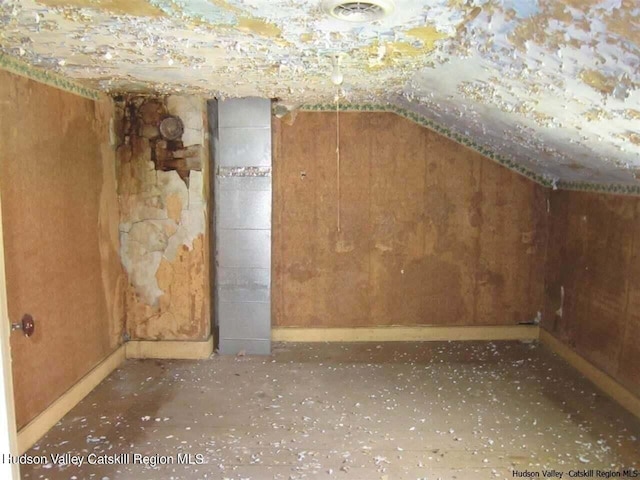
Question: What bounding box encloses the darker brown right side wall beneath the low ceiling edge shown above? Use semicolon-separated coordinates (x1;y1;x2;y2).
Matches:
543;191;640;396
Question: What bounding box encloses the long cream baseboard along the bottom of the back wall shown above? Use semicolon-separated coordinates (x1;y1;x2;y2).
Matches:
271;325;539;342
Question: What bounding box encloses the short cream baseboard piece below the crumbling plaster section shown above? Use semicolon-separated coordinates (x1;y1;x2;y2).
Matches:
126;335;213;360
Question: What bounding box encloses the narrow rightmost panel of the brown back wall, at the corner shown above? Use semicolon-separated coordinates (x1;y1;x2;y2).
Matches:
476;163;546;324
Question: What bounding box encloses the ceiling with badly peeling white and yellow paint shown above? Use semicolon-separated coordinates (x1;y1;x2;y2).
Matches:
0;0;640;189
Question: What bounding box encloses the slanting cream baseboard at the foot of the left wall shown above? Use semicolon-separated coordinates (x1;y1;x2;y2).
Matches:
18;345;125;455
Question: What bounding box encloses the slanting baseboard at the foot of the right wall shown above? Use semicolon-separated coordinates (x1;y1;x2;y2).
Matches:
540;329;640;418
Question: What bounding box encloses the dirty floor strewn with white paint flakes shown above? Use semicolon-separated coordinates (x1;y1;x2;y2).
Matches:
22;342;640;480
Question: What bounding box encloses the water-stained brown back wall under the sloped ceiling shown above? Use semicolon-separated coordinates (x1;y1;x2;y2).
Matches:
272;112;548;327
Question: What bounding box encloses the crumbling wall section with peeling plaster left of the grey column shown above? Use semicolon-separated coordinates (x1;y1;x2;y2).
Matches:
116;95;210;340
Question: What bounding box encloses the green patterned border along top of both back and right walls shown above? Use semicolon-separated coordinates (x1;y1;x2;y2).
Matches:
300;103;640;196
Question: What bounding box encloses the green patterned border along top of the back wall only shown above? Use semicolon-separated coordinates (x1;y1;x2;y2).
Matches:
300;103;553;188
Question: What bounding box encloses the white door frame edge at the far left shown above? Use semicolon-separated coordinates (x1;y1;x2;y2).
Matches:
0;193;20;480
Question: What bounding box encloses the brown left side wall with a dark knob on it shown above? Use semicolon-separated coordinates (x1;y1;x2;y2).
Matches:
0;71;122;427
